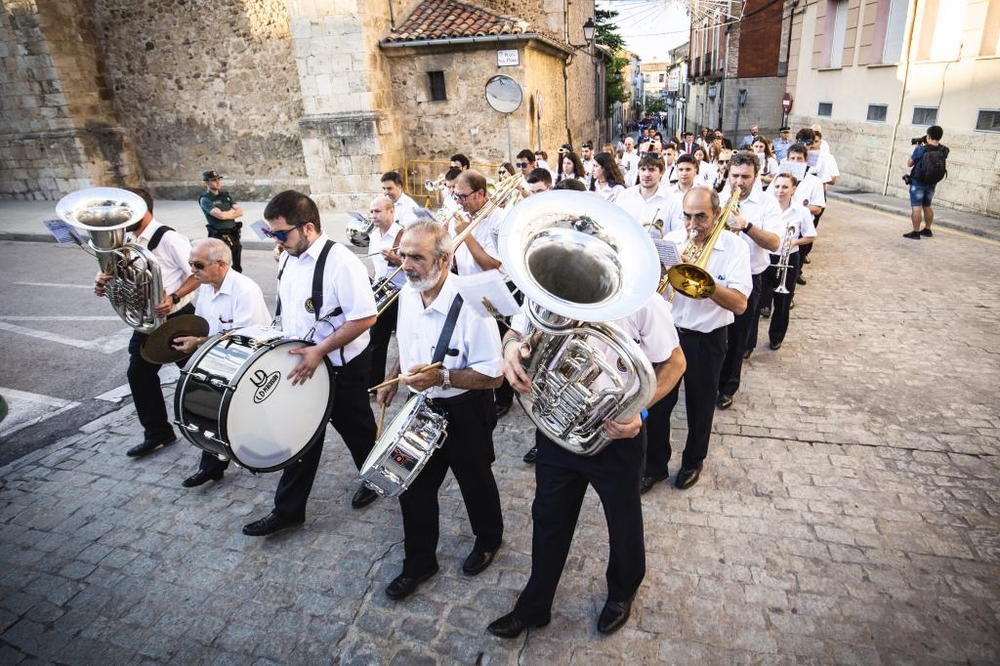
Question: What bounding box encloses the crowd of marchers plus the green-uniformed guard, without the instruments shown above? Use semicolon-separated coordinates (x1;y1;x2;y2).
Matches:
95;127;837;638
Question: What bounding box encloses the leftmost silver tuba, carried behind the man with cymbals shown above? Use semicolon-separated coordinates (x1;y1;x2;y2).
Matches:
56;187;166;333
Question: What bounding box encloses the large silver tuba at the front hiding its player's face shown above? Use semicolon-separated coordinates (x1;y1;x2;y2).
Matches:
500;191;659;456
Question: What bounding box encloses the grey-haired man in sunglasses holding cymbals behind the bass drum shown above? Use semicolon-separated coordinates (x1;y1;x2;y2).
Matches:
172;238;271;488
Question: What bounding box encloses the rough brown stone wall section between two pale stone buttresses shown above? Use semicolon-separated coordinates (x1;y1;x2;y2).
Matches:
94;0;308;200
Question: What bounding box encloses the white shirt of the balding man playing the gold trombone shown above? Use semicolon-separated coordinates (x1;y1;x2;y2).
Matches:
665;230;753;333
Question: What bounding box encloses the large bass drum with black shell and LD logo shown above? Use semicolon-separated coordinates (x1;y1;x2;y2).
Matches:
174;326;333;472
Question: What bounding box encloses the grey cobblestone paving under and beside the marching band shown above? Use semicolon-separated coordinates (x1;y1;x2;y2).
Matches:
0;203;1000;664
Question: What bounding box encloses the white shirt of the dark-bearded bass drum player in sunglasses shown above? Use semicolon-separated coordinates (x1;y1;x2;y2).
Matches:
278;232;377;365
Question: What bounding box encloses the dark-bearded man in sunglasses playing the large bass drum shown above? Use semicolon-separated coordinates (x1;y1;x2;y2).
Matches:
243;190;377;536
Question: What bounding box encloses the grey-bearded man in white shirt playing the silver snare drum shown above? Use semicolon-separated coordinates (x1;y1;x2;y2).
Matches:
378;219;503;600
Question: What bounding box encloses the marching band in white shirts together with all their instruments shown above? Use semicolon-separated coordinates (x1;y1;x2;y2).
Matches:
68;134;816;638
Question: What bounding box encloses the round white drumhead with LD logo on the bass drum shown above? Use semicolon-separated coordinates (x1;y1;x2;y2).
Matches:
222;340;333;472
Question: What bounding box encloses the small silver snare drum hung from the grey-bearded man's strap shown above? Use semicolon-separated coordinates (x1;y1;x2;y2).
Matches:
360;395;448;497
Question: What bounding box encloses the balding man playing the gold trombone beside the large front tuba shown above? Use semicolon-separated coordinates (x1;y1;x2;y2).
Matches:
639;187;753;493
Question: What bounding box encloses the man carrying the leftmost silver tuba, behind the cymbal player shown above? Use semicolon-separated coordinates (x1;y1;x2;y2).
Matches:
94;188;198;458
